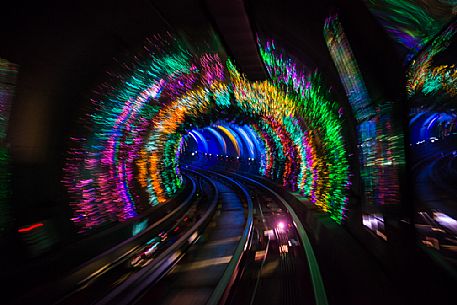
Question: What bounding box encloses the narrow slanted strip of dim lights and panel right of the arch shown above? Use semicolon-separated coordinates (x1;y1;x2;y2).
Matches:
324;16;404;213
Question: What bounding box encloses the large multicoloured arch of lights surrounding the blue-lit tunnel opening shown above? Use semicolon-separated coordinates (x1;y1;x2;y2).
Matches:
63;37;349;231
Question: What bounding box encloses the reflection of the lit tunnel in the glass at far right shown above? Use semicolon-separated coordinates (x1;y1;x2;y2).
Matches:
406;19;457;261
